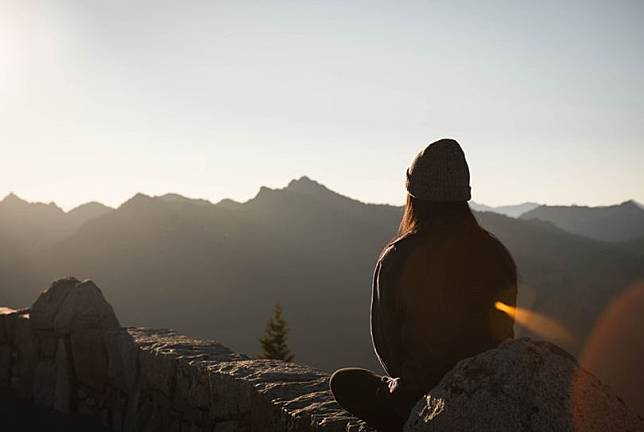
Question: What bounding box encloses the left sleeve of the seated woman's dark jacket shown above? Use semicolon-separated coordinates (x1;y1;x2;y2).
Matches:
371;246;406;377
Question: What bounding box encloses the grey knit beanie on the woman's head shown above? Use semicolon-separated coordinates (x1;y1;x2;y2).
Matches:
406;138;471;201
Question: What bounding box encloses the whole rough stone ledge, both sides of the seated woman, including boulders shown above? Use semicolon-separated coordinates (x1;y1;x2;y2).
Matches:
0;278;644;432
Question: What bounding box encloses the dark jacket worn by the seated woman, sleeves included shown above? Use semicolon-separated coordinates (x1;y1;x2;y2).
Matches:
371;228;517;394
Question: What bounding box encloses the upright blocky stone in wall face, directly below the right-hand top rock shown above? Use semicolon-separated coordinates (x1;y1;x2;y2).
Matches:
70;330;107;394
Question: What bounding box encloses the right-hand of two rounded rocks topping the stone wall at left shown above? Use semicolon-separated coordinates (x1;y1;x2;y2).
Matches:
54;280;120;334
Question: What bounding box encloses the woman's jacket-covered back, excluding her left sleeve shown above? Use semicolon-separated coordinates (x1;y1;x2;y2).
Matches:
400;229;516;386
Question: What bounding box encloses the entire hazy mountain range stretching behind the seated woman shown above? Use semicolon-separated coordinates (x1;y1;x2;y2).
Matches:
0;177;644;414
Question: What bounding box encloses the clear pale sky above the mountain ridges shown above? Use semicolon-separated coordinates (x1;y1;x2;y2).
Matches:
0;0;644;209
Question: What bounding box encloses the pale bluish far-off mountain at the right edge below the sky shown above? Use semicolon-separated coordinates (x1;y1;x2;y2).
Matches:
521;201;644;242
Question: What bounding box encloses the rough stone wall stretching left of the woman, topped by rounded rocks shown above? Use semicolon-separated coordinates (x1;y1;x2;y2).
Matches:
0;278;367;432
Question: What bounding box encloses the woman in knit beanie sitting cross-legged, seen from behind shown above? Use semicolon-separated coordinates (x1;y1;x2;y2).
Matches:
330;139;517;432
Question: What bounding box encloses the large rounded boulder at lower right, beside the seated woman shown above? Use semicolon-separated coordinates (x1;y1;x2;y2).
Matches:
404;338;644;432
